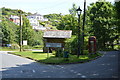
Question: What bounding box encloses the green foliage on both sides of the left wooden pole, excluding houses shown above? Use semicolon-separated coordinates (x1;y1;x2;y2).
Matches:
0;7;43;46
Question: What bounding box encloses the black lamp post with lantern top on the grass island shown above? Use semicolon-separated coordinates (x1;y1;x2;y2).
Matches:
76;7;82;58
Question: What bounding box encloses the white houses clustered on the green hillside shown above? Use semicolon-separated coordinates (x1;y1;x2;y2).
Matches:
9;13;50;30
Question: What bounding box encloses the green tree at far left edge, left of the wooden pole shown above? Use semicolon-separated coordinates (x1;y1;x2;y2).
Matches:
0;17;18;44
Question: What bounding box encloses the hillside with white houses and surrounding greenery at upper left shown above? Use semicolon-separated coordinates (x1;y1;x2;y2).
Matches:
0;7;56;30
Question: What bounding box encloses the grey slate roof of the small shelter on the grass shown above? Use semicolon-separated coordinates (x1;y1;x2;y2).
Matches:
43;30;72;38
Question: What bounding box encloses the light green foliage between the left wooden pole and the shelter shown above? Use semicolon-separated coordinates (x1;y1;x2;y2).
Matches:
22;17;43;46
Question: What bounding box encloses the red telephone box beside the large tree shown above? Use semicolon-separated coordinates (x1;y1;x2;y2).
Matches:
89;36;96;53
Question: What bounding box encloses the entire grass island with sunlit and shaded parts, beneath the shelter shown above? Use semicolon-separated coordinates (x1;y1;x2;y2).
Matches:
13;51;101;64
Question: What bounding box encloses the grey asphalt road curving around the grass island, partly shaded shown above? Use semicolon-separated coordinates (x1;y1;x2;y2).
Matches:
0;51;120;78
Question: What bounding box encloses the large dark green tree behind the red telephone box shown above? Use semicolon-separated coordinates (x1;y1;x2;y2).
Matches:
87;2;116;49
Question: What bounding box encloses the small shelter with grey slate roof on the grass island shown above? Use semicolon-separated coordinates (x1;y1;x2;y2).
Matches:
43;30;72;52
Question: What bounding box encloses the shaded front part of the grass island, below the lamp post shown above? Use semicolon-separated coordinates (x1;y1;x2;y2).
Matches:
39;53;101;64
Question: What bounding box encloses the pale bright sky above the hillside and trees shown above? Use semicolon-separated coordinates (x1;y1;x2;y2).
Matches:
0;0;114;15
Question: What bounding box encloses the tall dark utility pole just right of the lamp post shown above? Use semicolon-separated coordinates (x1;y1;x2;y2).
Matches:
81;0;86;54
